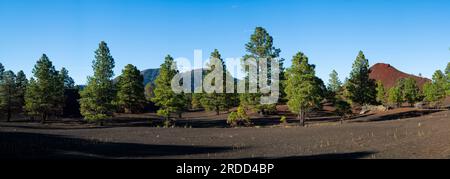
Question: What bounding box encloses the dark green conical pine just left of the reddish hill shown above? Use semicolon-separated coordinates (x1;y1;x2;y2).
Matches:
347;51;376;105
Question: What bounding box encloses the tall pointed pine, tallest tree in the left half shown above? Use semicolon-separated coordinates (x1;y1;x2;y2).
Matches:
80;41;115;125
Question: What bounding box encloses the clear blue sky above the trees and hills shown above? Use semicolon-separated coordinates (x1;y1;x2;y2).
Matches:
0;0;450;84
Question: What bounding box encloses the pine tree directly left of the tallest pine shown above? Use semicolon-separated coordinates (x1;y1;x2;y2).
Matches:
200;49;230;115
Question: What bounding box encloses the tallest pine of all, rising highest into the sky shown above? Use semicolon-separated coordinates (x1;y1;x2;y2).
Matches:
240;27;284;113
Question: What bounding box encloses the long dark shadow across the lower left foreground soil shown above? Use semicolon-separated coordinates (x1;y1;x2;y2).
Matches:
0;132;236;159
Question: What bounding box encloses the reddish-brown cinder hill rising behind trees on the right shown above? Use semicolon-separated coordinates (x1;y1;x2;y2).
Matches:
369;63;430;89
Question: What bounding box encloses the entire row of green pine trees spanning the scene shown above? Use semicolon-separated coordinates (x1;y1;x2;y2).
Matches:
0;27;450;125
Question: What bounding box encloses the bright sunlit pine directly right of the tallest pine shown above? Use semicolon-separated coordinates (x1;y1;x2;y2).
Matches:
285;52;323;126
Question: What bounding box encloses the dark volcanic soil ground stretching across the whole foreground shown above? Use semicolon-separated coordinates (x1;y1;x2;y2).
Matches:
0;111;450;159
